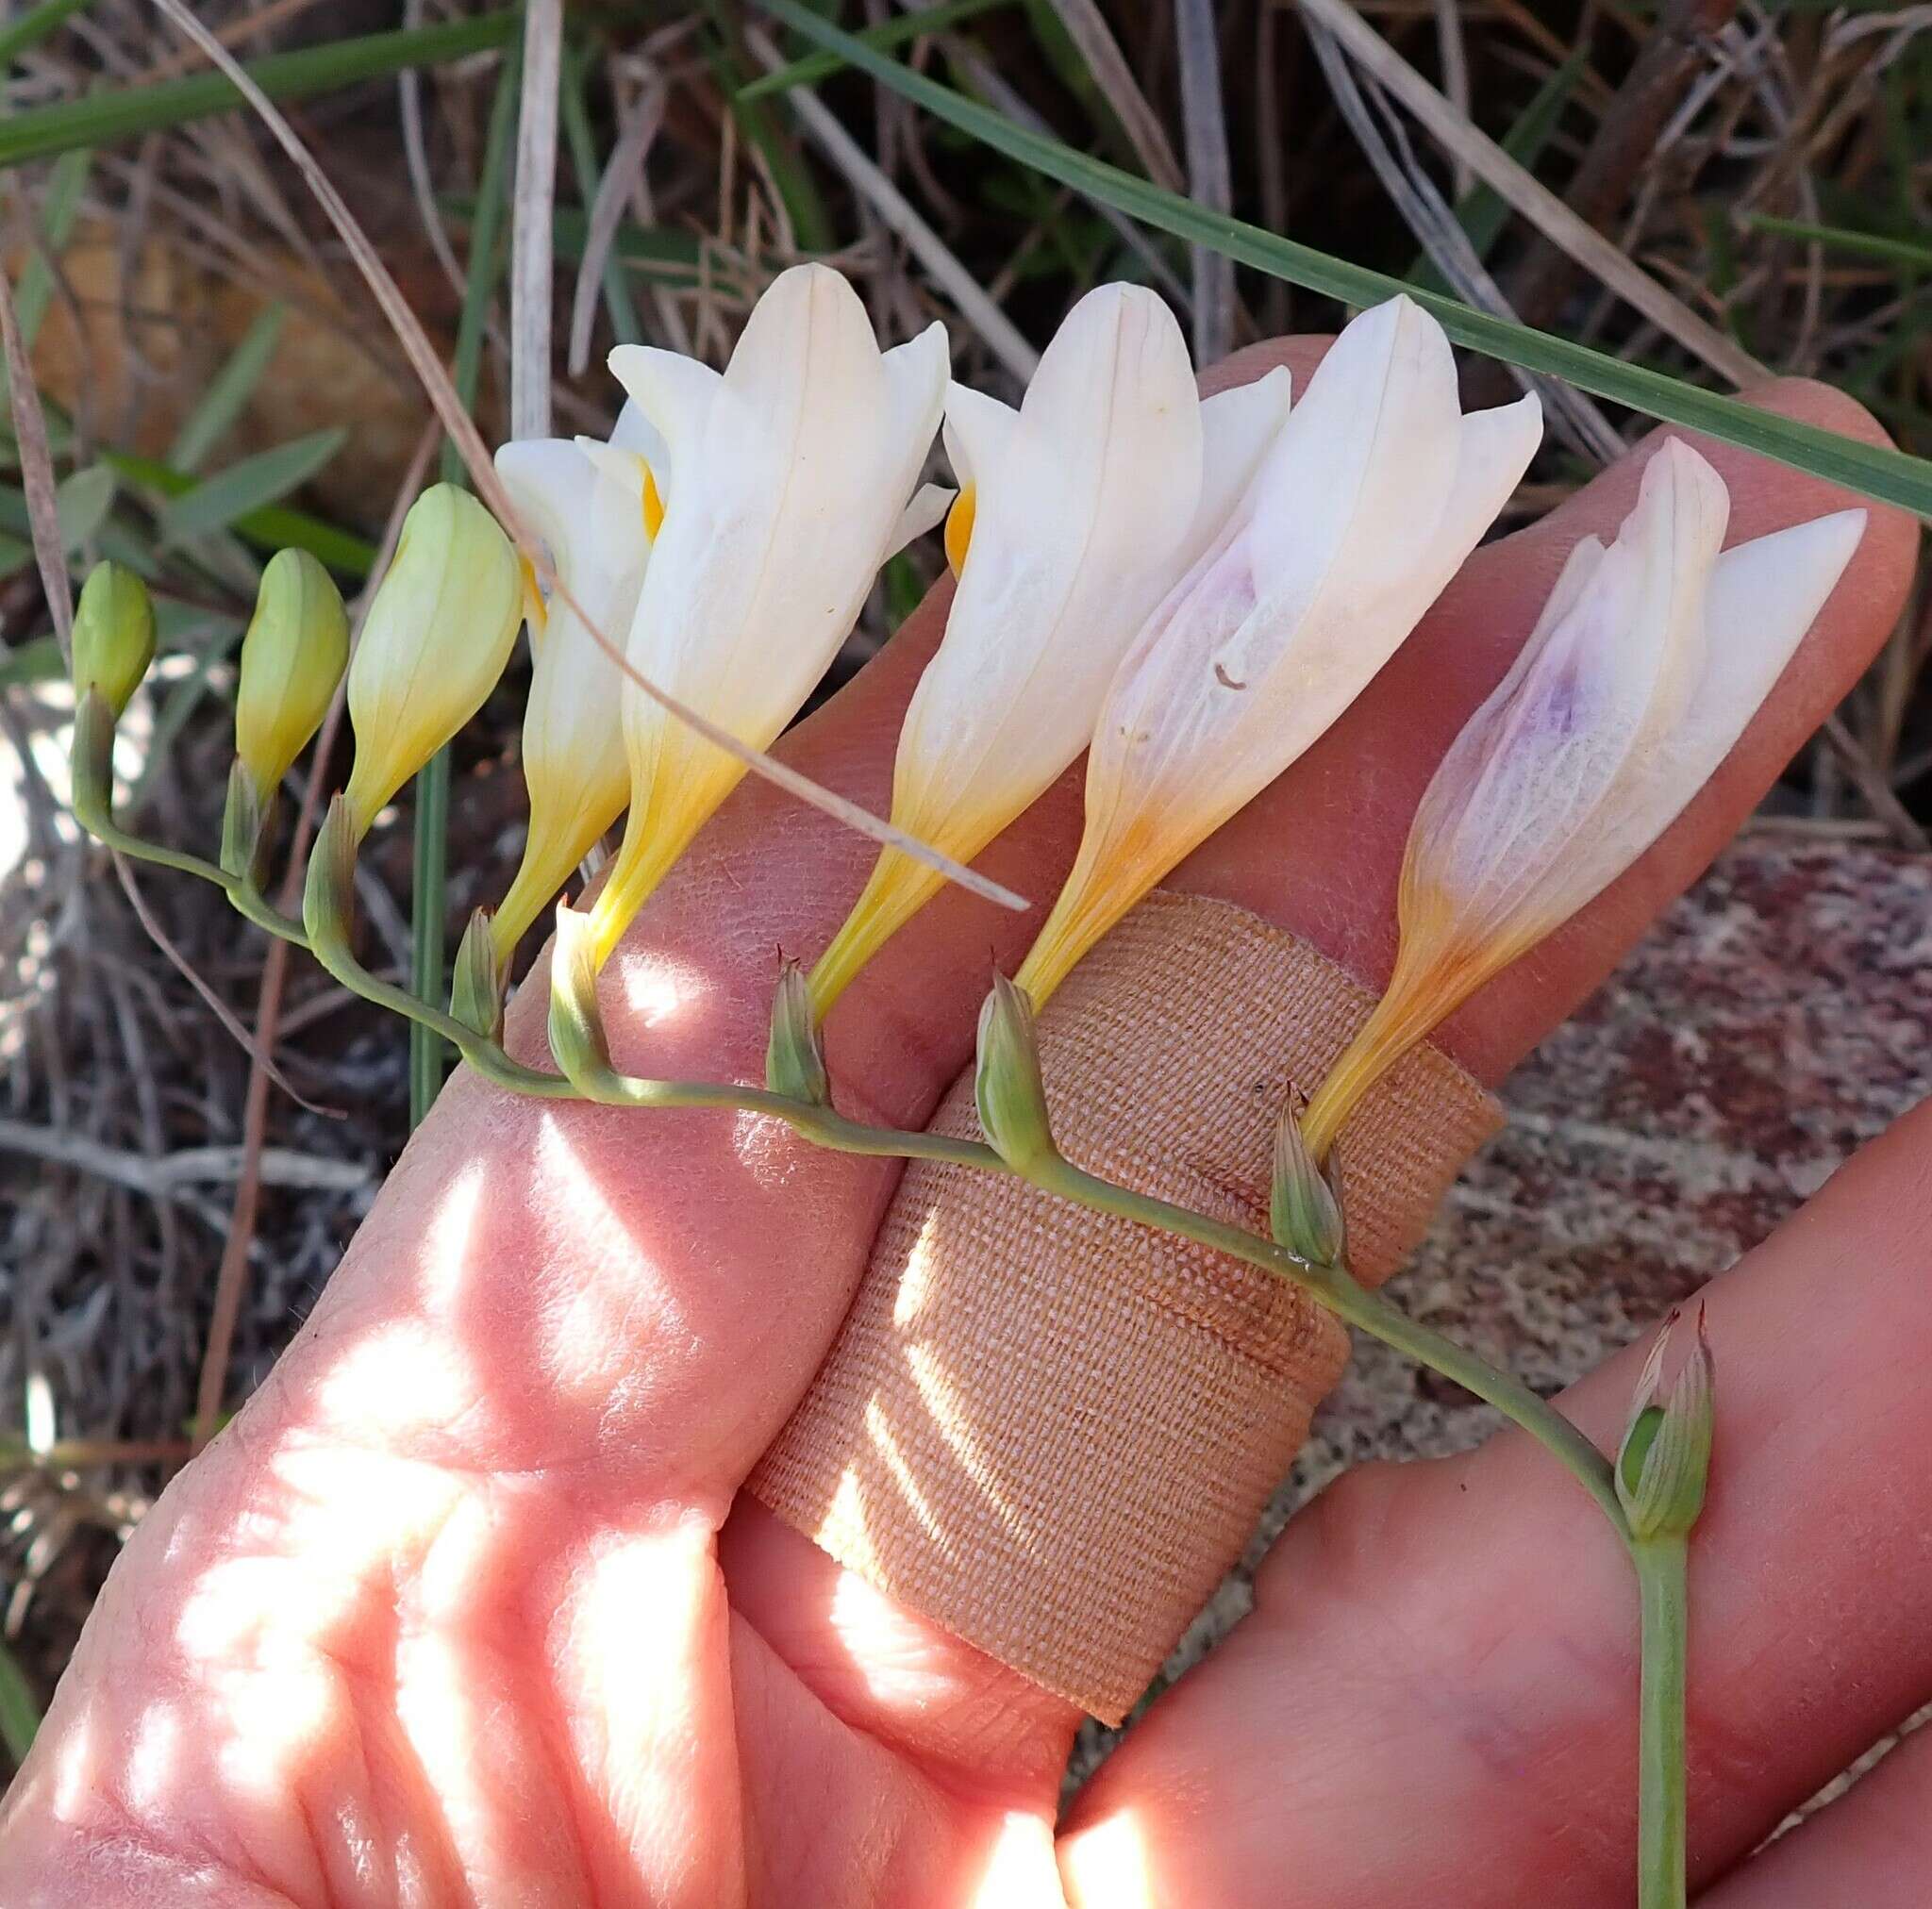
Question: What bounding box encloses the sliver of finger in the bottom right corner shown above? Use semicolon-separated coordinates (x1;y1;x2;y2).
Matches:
1698;1729;1932;1909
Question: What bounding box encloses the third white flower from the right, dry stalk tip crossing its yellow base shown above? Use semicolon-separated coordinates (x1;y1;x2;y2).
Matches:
811;286;1289;1015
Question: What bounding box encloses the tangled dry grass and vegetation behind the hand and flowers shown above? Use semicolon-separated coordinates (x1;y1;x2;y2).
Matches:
0;0;1932;1751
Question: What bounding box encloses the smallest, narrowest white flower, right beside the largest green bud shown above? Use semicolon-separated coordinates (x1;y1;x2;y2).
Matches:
491;436;669;964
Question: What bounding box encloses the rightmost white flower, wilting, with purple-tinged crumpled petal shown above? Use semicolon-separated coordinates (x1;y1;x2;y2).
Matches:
1304;439;1864;1154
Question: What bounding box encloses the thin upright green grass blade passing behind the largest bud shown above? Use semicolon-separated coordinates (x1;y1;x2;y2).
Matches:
409;54;524;1128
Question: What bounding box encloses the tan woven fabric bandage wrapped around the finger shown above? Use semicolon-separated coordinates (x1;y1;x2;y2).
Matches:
750;890;1501;1723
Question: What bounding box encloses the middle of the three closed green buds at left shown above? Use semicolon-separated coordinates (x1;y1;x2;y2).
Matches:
236;551;350;807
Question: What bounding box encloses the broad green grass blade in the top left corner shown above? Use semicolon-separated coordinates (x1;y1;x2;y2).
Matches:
0;9;522;168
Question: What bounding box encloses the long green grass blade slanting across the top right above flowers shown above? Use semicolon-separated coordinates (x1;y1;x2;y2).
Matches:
761;0;1932;516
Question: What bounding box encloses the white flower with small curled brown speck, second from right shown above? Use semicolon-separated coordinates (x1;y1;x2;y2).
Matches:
1018;297;1541;1003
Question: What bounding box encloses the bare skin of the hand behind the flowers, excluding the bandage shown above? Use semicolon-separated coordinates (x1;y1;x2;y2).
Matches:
0;340;1932;1909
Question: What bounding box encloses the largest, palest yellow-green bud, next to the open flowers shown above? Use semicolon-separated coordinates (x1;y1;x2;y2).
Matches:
346;483;524;837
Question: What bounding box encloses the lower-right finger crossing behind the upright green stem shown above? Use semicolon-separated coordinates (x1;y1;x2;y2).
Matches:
1062;1107;1932;1909
